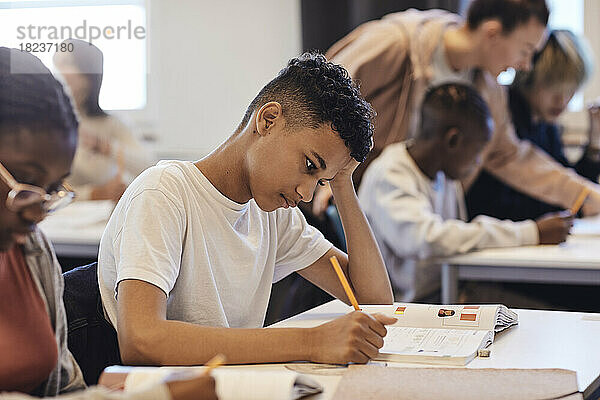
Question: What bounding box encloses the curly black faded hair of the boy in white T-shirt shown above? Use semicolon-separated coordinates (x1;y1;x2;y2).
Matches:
237;52;375;162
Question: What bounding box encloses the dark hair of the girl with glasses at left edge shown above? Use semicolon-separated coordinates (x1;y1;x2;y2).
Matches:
0;47;78;135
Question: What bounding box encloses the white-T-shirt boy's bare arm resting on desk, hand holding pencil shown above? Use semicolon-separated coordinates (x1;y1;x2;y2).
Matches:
117;280;395;365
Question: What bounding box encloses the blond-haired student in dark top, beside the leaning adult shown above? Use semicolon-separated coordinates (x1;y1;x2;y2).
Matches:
467;30;600;221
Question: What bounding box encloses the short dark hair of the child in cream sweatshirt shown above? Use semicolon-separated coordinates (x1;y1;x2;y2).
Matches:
417;83;493;141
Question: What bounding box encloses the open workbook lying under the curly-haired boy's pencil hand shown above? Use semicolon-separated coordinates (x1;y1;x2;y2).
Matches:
361;303;518;365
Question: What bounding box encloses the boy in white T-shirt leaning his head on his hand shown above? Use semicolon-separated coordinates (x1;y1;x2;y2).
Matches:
98;53;395;365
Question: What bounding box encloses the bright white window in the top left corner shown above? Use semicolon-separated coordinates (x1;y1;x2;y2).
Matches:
0;0;147;110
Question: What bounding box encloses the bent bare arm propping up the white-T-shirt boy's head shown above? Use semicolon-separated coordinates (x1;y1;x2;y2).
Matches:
298;159;394;304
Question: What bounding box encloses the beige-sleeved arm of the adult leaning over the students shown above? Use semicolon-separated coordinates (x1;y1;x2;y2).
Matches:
472;76;600;215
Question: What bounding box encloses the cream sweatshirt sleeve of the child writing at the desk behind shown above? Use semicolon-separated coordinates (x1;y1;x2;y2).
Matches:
361;169;552;258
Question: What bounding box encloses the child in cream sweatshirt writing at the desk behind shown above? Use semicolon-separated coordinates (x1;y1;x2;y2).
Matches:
359;84;573;302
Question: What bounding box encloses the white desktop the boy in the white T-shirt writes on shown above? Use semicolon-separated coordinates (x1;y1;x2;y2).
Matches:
273;300;600;399
